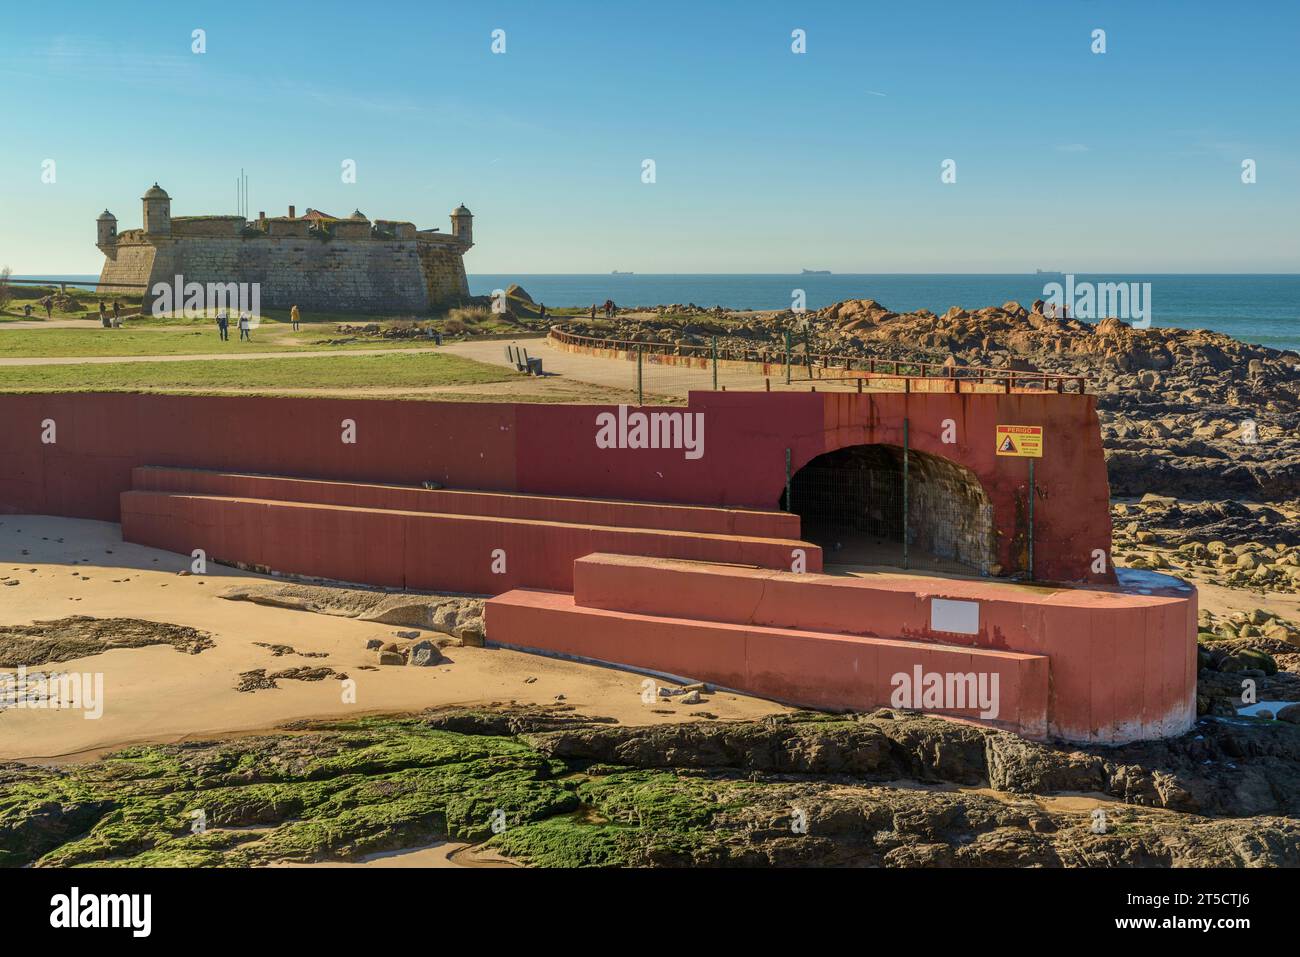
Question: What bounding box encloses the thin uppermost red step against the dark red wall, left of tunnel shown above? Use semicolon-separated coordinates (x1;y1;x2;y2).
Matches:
131;467;800;538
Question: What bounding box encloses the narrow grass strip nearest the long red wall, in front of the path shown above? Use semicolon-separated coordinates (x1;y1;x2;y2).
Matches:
0;352;523;393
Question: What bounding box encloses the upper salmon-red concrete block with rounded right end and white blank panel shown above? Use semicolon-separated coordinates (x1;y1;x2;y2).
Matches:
573;555;1196;742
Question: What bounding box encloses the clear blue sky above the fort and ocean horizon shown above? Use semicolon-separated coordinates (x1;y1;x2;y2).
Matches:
0;0;1300;274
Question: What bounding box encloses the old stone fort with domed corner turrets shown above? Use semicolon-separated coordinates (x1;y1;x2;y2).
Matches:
96;183;473;313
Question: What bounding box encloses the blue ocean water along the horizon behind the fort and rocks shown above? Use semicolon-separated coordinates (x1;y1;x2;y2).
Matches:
14;273;1300;351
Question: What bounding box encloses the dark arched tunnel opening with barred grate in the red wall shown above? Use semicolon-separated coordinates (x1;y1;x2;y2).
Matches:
780;445;1000;575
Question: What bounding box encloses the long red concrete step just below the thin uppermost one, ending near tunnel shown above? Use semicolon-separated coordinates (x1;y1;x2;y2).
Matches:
122;492;822;594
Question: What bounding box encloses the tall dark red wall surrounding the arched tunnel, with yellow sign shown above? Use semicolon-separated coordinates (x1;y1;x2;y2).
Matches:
0;393;1113;581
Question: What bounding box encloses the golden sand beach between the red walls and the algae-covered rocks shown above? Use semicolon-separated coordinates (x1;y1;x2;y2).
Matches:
0;515;785;761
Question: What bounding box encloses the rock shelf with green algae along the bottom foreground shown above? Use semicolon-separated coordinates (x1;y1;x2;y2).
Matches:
0;707;1300;867
